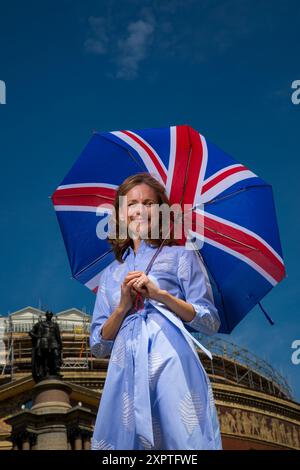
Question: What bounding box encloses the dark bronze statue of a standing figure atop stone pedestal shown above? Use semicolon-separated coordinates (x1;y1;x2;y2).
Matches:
28;310;62;382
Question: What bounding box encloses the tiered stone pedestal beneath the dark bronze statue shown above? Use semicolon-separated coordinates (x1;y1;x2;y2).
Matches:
6;377;94;450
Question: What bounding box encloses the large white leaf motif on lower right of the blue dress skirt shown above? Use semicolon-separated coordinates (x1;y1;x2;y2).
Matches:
179;392;203;434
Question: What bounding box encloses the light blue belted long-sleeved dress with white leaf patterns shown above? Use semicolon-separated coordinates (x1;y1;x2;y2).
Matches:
90;240;222;450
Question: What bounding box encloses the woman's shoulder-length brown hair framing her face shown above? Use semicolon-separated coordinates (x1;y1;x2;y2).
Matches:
108;173;178;263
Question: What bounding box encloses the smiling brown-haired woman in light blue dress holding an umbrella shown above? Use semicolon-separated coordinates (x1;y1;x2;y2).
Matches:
90;173;222;450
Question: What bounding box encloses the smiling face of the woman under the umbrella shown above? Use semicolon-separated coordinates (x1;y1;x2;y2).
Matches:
121;183;158;238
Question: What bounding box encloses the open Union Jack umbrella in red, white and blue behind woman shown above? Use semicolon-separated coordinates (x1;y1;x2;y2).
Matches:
52;125;285;333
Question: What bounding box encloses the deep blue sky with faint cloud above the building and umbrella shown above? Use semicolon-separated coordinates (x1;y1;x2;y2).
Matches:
0;0;300;400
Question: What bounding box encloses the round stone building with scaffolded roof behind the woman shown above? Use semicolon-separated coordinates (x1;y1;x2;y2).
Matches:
0;307;300;450
